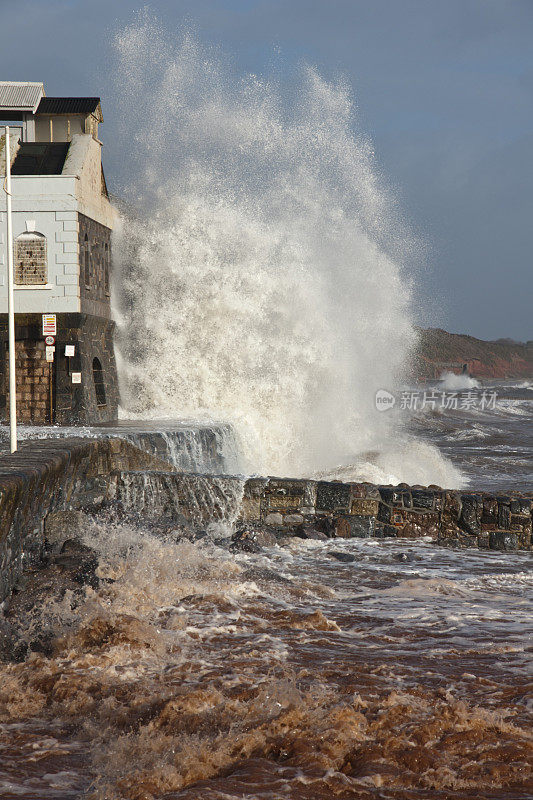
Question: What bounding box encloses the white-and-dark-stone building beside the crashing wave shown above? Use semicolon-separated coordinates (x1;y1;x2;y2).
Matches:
0;82;118;424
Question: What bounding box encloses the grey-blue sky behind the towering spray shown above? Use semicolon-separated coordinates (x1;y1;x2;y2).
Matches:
0;0;533;341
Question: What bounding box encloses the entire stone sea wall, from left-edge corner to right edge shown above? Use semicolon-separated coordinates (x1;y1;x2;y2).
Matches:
0;438;533;601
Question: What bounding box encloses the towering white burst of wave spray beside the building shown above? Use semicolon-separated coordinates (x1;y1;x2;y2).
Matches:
114;12;460;486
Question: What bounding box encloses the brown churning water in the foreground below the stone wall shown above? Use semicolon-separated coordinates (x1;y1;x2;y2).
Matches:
0;522;533;800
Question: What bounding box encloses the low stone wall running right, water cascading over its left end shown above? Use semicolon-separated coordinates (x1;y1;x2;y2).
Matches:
106;472;533;550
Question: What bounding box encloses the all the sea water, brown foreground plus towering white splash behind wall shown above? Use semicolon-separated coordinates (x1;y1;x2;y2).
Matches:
0;16;533;800
